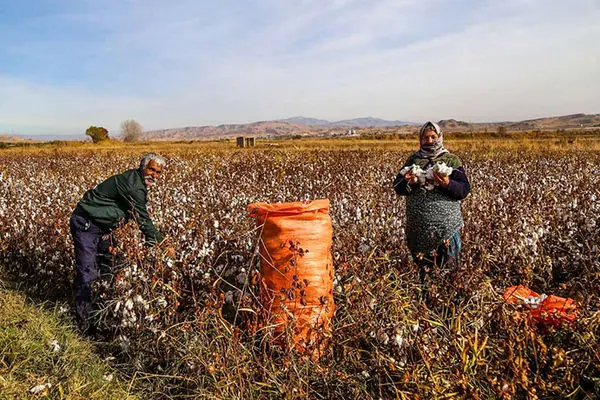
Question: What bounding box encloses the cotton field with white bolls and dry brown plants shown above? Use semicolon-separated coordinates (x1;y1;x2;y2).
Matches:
0;147;600;399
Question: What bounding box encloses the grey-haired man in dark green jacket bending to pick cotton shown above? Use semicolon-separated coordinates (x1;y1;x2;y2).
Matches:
70;153;175;333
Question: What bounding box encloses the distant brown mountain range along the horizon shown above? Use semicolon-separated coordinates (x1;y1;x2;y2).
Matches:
0;114;600;142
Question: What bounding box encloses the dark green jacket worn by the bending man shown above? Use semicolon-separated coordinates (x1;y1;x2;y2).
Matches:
75;169;163;243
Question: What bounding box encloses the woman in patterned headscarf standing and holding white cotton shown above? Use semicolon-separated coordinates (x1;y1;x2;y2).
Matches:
394;121;470;282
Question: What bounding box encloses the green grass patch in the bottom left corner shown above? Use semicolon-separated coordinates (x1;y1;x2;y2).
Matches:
0;281;136;400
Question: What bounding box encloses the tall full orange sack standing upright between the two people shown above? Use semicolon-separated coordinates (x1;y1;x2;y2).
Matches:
248;199;335;357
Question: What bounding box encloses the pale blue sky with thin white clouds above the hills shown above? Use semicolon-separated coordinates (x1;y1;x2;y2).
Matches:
0;0;600;135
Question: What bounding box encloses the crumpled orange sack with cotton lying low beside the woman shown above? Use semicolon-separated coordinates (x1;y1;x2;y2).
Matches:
503;285;577;326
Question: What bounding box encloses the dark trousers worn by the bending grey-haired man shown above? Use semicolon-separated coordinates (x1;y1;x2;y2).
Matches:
69;214;113;324
